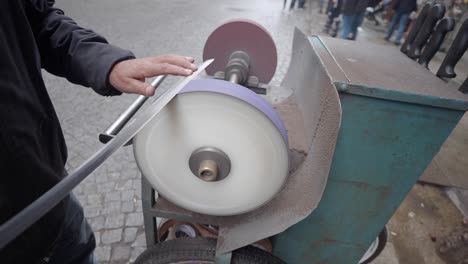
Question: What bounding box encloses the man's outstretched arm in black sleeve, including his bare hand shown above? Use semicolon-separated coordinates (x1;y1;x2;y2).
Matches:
26;0;196;95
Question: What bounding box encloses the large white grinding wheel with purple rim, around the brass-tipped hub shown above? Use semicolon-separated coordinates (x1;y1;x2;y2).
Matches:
134;80;288;216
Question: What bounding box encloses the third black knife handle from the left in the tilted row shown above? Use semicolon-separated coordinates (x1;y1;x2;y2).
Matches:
418;17;455;68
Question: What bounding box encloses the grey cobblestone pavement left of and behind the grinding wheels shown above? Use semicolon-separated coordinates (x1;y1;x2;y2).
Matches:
44;0;324;263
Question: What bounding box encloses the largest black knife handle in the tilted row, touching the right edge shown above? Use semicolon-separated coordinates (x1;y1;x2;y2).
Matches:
437;20;468;78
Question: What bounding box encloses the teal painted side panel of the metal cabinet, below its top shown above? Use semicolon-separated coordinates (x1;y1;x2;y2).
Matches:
274;93;464;264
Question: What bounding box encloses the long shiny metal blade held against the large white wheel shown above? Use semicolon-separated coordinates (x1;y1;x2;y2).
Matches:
0;59;213;249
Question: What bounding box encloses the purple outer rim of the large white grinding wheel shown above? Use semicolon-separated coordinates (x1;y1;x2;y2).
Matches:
179;79;289;146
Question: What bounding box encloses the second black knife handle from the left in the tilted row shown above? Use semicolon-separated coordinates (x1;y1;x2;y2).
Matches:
407;4;445;59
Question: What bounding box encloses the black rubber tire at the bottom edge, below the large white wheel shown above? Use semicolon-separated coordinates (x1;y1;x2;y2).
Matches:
135;237;285;264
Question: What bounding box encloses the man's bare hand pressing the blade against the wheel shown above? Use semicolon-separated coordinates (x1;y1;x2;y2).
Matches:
109;54;197;96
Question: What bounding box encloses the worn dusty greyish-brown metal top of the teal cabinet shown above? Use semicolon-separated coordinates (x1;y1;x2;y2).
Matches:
320;37;468;110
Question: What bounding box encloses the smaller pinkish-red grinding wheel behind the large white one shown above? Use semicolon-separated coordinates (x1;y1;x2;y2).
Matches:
203;20;278;84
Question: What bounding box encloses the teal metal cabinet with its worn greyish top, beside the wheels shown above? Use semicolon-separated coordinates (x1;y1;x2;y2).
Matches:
274;35;466;264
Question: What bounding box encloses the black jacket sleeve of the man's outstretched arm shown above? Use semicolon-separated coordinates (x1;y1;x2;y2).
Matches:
26;0;135;95
